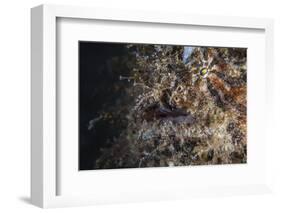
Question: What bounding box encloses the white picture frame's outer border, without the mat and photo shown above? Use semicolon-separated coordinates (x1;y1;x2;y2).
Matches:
31;5;274;208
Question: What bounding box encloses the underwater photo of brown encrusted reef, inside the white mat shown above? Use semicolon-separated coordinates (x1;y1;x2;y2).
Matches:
78;41;247;170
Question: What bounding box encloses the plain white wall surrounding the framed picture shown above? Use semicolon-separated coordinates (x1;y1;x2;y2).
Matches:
0;0;281;213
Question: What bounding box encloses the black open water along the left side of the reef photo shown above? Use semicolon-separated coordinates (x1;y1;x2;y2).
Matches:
79;41;129;170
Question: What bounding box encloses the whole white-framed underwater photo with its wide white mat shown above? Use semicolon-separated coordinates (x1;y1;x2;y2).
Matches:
31;5;273;207
